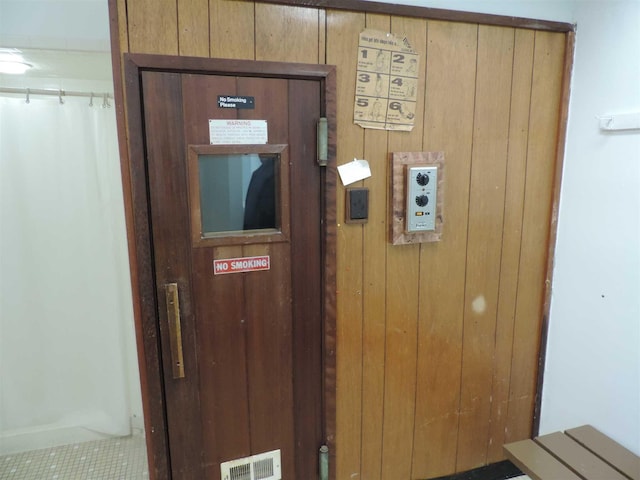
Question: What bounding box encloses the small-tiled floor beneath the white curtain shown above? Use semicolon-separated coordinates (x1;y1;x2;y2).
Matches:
0;435;149;480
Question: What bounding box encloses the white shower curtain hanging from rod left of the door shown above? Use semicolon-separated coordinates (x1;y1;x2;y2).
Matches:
0;96;137;450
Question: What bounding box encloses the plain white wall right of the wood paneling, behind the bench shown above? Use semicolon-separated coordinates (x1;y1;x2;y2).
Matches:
376;0;640;454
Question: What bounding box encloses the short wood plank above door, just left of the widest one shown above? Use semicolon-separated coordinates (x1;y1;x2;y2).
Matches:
209;0;255;60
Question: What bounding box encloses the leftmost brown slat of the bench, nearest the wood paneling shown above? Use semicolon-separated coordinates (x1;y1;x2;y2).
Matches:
504;440;581;480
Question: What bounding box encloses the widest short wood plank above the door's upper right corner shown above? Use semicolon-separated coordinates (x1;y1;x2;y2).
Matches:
256;3;324;63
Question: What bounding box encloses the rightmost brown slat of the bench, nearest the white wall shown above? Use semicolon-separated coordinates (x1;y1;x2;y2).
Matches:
565;425;640;480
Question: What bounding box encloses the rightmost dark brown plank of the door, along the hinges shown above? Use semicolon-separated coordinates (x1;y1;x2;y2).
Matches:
288;80;324;477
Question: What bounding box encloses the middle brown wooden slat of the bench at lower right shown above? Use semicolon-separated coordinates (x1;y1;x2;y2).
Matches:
535;432;628;480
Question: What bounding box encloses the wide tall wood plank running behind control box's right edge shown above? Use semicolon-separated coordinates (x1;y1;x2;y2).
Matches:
413;22;478;478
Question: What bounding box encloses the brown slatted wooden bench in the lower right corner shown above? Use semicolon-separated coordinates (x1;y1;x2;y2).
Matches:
504;425;640;480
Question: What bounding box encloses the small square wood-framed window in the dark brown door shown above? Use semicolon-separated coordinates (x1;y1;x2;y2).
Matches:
189;145;289;246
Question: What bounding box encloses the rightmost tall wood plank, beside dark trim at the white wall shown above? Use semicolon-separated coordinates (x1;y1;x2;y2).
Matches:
505;32;565;441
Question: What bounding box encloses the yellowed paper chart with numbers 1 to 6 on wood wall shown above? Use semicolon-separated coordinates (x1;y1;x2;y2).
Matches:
353;30;419;131
